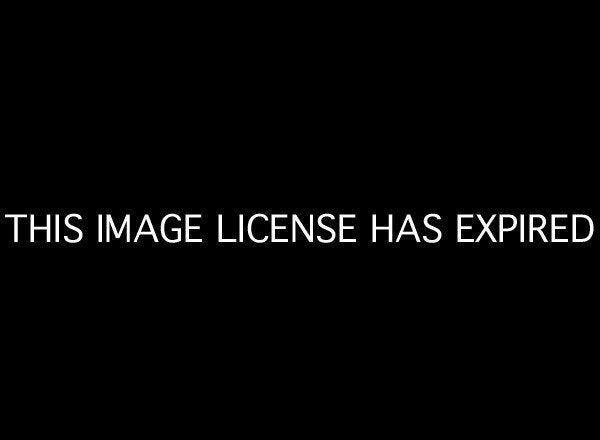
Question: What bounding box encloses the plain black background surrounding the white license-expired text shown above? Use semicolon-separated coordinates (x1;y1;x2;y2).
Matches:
1;5;598;433
